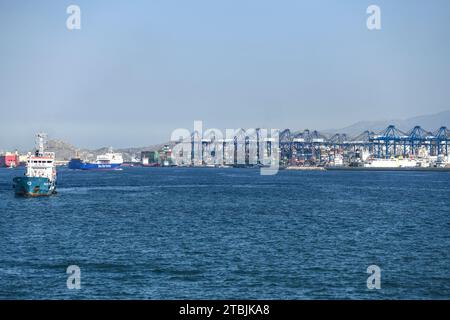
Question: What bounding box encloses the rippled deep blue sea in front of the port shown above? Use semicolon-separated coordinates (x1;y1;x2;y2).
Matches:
0;168;450;299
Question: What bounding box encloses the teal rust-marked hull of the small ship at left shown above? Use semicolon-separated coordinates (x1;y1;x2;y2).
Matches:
13;177;56;197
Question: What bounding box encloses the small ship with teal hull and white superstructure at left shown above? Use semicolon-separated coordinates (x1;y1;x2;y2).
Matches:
13;133;56;197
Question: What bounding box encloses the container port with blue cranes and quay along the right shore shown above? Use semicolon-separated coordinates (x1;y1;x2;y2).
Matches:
174;125;450;167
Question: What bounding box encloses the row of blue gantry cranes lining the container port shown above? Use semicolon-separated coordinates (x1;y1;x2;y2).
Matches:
185;125;450;165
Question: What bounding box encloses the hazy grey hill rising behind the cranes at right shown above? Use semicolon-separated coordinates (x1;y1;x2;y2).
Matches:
324;110;450;136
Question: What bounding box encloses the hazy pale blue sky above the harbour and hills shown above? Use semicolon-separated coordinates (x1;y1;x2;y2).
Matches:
0;0;450;149
